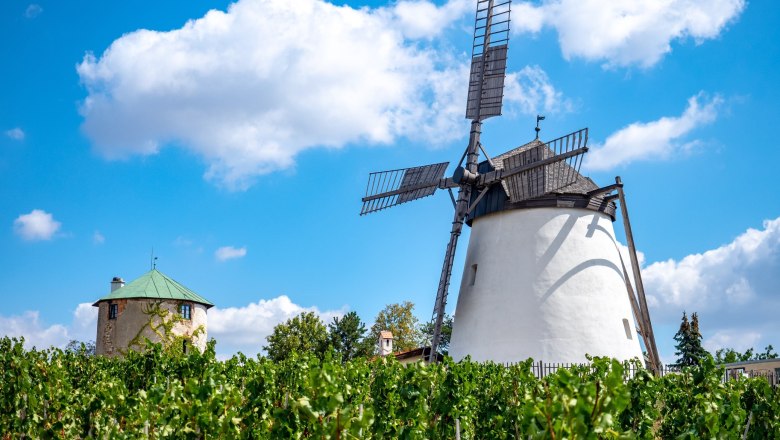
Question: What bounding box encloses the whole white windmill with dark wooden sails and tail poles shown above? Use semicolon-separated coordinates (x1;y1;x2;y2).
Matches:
360;0;659;370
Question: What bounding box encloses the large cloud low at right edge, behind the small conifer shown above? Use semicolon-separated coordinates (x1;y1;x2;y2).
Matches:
642;218;780;350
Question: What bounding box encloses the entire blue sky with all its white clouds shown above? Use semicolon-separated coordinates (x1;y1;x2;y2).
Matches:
0;0;780;362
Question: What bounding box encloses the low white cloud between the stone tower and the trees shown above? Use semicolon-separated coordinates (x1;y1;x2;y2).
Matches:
208;295;345;356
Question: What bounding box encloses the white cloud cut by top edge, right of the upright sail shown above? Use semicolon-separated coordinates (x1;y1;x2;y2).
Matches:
512;0;746;67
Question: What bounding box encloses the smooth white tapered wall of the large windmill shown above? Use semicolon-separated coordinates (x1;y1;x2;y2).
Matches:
450;208;642;362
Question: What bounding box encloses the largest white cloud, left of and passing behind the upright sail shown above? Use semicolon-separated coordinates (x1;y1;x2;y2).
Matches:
77;0;562;190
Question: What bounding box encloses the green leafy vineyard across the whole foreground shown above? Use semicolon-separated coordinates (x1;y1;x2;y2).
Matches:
0;338;780;439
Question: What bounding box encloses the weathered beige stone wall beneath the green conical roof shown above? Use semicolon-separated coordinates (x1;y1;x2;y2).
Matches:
95;298;207;356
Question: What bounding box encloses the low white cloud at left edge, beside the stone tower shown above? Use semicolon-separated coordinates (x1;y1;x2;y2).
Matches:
0;303;97;349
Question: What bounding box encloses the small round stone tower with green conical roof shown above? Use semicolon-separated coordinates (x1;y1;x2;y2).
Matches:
93;269;214;356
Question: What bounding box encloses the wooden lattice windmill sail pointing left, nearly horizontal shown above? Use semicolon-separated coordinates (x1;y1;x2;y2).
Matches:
360;162;449;215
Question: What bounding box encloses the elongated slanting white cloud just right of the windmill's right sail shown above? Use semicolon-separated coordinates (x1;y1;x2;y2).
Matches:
585;93;723;171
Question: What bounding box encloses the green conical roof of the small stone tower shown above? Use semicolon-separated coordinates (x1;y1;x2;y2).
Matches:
93;269;214;308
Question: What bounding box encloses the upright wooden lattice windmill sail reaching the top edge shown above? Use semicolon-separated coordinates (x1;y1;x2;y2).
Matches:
466;0;510;121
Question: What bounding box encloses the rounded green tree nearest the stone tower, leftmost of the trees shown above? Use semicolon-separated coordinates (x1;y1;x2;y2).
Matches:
263;312;328;361
